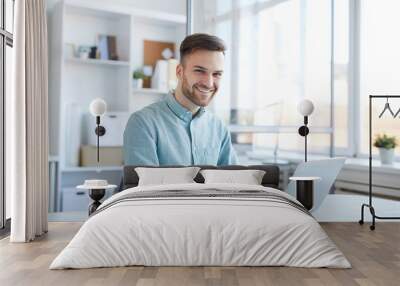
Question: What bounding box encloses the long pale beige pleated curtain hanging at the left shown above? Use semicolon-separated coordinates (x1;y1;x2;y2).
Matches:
6;0;48;242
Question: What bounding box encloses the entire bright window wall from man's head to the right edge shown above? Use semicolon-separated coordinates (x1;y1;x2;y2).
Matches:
194;0;400;160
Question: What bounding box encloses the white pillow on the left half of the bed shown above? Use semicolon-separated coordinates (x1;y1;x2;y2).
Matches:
135;167;200;186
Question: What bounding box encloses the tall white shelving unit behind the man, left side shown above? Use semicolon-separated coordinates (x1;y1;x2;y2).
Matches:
49;0;186;211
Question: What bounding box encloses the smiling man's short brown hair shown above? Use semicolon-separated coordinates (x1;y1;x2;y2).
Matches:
179;33;226;63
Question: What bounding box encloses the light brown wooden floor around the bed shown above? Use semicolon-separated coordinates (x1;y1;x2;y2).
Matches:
0;222;400;286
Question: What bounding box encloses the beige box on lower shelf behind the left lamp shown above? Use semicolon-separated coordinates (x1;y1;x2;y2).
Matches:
80;145;124;167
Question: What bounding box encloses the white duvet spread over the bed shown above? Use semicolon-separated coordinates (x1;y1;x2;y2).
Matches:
50;184;351;269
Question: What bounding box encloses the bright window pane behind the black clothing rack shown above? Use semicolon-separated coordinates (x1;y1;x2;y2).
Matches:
359;0;400;158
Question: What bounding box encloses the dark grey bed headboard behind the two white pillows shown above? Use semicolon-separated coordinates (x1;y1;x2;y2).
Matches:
122;165;279;190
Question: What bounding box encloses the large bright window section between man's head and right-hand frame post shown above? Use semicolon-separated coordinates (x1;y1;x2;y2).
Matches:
194;0;334;154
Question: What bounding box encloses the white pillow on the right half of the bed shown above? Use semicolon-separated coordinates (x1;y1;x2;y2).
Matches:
200;170;265;185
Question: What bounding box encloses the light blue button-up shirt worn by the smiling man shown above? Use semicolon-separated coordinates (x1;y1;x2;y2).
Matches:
124;94;238;166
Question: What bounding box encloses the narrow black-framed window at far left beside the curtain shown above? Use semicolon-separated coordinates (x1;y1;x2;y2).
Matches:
0;0;14;229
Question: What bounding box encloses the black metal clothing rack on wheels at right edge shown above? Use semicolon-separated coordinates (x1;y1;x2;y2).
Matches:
359;95;400;230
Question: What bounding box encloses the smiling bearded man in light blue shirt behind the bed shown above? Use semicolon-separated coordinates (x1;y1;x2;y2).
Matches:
124;34;237;166
